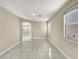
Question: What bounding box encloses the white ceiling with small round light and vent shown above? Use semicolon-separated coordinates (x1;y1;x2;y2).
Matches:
0;0;69;21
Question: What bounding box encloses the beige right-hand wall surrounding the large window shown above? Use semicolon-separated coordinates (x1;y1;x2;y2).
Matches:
48;0;78;59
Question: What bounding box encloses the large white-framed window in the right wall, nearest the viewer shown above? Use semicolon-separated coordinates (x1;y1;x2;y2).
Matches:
64;5;78;43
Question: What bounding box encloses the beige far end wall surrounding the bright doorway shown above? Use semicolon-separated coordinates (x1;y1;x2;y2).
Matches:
20;18;47;39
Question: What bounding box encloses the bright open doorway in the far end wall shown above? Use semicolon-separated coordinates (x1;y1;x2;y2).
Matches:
22;22;31;41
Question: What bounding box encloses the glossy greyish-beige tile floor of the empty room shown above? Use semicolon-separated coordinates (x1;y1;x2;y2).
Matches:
0;39;66;59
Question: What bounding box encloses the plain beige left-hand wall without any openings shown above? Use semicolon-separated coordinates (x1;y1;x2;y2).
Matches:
0;7;20;53
